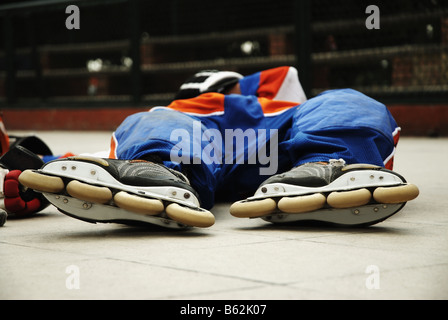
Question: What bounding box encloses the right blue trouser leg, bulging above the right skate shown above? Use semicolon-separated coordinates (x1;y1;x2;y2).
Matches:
285;89;397;166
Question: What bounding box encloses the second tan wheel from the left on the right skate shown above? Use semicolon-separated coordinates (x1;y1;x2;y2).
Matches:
278;193;326;213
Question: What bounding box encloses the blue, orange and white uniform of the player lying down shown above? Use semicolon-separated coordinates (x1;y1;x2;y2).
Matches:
110;67;400;208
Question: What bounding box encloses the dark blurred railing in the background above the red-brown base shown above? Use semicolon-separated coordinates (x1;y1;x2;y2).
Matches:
0;0;448;133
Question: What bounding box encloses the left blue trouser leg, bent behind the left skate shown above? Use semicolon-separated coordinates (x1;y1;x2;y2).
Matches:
114;109;219;209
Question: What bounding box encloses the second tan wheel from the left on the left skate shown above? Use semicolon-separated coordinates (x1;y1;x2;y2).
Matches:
66;180;112;204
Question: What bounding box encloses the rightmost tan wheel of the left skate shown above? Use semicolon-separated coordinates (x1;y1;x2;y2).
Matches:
165;203;215;228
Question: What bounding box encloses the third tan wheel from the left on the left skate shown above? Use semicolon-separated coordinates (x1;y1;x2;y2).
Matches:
114;191;164;215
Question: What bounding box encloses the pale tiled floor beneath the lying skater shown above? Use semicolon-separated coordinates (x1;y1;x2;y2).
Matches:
0;132;448;300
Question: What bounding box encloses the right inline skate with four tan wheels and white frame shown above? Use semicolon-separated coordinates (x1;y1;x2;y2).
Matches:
230;159;419;226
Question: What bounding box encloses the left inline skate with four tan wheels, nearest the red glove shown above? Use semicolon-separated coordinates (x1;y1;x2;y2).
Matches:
19;156;215;229
